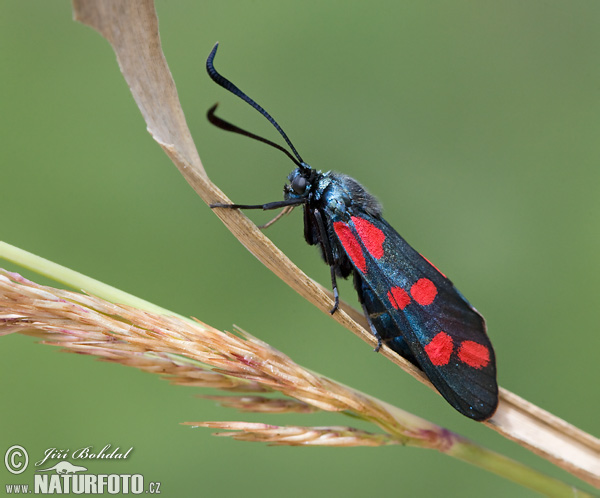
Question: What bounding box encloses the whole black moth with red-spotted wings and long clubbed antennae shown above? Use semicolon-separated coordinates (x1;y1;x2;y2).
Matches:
206;44;498;420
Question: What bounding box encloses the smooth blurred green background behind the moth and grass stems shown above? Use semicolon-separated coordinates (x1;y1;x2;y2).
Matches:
0;0;600;497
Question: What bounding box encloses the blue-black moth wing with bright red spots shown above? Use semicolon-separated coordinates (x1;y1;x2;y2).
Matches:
328;209;498;420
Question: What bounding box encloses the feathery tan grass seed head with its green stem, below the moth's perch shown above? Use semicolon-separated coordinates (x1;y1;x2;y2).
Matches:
0;255;589;496
